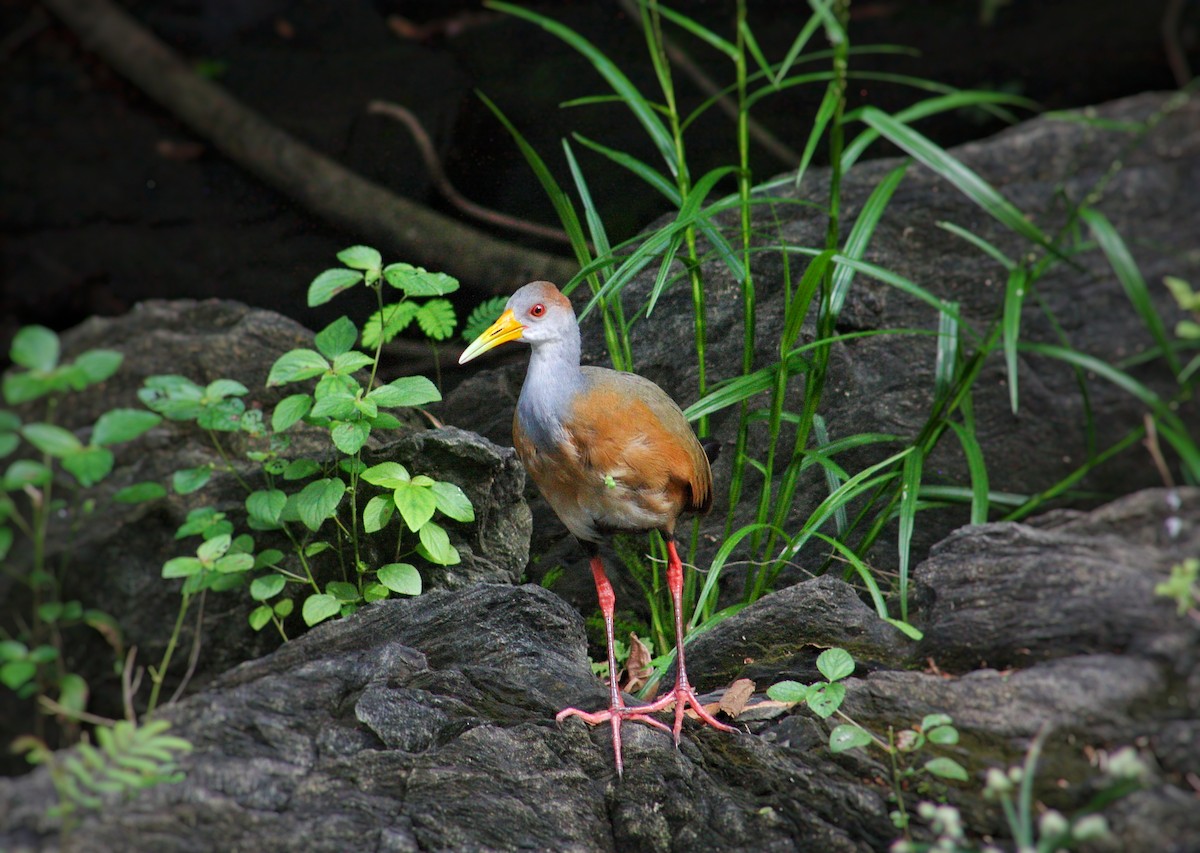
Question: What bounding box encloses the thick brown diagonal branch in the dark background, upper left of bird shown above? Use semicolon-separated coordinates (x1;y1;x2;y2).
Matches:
42;0;578;293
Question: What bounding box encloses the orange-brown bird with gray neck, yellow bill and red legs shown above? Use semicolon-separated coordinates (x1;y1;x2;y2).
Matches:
458;281;737;776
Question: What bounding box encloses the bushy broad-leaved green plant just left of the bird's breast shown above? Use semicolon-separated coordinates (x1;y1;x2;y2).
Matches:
140;246;474;638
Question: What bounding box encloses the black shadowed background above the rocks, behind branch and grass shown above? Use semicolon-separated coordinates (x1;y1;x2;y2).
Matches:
0;0;1200;364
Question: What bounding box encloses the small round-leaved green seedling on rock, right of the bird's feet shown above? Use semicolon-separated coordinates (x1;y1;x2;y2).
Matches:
767;648;968;835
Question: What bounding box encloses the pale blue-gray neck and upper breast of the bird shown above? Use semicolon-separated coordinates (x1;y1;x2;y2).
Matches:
517;323;583;449
